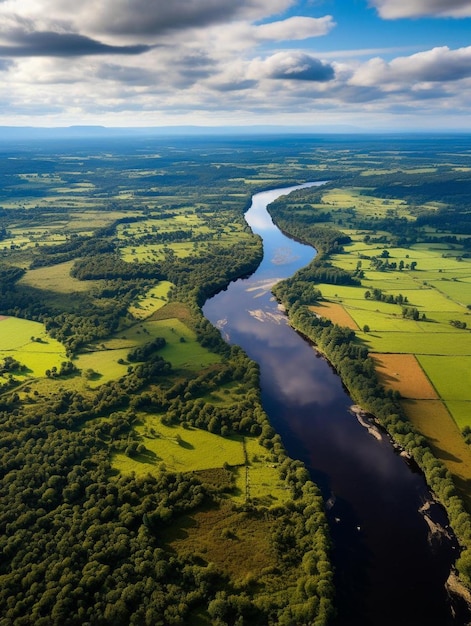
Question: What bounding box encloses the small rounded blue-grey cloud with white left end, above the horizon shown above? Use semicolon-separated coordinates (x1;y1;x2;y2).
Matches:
251;51;335;82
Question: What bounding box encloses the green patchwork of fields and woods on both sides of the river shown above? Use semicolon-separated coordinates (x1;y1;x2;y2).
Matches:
0;134;471;626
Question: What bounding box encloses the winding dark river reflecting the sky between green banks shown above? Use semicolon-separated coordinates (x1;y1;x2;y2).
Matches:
203;183;463;626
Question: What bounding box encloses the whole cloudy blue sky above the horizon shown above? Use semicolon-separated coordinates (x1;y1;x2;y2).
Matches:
0;0;471;131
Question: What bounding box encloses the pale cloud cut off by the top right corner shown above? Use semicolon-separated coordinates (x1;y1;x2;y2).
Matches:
370;0;471;19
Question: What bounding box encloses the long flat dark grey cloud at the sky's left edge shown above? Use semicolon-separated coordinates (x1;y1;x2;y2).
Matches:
0;31;154;57
